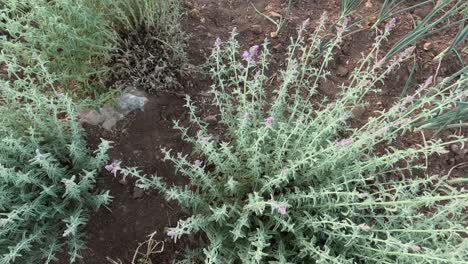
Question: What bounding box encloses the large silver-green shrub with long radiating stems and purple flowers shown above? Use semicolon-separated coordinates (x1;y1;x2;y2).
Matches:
122;19;468;264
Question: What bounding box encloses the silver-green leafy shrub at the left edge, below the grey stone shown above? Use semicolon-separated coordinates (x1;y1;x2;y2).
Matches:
0;83;110;264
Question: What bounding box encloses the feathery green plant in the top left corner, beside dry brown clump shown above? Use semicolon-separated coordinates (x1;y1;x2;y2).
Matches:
0;0;116;98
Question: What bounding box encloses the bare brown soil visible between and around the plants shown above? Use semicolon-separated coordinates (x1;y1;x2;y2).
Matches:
63;0;466;264
